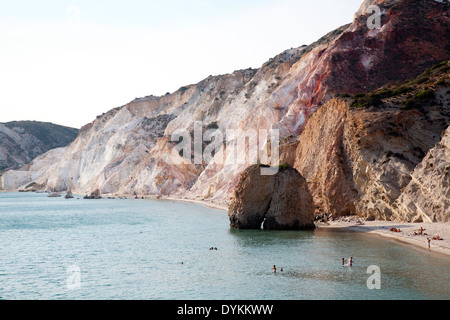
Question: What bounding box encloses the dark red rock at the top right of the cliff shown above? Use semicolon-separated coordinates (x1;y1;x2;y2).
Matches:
286;0;450;134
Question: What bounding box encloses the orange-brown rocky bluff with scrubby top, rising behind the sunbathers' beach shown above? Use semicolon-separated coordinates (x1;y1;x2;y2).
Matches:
293;62;450;222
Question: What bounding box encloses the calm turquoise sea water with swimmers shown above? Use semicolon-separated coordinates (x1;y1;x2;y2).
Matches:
0;193;450;300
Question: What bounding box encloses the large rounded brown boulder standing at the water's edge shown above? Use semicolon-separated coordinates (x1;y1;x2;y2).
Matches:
228;165;315;230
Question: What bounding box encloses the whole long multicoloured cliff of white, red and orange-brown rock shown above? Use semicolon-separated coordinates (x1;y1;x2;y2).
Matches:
0;0;450;222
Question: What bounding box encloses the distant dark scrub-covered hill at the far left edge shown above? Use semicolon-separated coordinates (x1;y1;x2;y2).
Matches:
0;121;78;171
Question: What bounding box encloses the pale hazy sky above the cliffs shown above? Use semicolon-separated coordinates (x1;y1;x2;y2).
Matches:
0;0;362;128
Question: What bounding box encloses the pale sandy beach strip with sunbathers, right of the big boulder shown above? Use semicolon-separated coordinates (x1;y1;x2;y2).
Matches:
318;217;450;255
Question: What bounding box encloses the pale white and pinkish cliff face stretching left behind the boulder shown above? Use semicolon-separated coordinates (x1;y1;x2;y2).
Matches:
0;37;340;199
